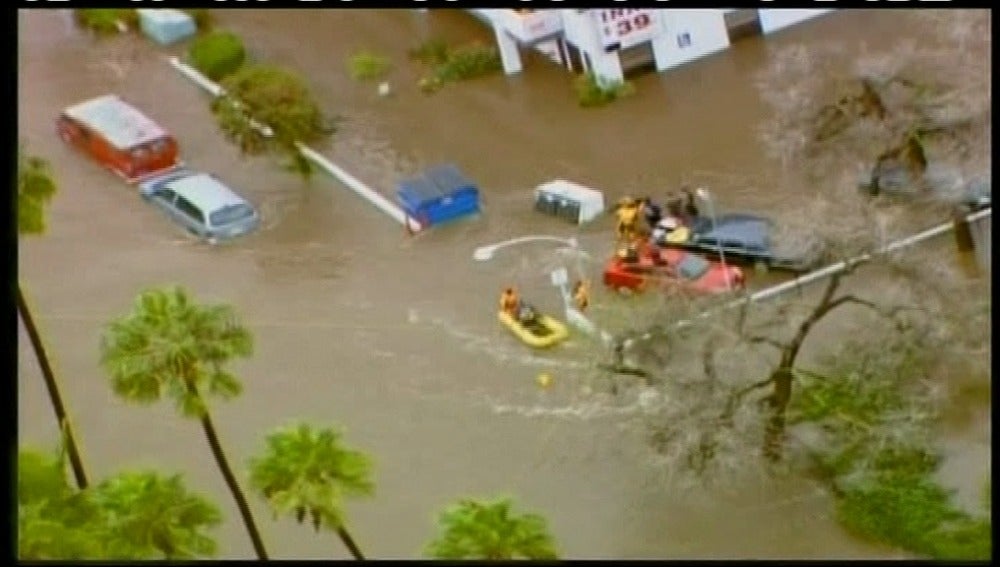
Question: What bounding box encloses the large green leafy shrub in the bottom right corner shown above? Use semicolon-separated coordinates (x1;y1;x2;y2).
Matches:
789;335;992;560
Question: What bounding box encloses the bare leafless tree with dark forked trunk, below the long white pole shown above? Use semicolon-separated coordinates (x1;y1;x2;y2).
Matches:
607;236;988;492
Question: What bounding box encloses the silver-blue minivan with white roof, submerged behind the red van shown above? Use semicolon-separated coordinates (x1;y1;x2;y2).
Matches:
139;169;260;244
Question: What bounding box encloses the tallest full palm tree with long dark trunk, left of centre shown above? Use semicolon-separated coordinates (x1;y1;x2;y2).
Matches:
101;287;267;560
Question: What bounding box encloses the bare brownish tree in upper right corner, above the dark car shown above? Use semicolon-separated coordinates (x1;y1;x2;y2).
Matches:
759;10;991;205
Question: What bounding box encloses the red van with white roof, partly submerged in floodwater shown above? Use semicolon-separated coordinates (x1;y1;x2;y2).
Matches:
56;95;180;183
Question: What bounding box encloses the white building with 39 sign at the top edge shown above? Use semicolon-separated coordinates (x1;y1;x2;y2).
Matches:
469;8;831;86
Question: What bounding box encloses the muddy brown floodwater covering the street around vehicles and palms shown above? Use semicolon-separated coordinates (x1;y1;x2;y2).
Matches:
19;10;988;558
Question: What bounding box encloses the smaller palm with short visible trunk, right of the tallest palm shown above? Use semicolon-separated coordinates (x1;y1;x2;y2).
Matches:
250;423;375;559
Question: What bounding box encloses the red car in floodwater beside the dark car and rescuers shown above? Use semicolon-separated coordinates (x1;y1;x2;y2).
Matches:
604;247;746;294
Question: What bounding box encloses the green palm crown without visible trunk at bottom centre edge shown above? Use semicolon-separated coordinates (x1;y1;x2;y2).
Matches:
426;498;557;560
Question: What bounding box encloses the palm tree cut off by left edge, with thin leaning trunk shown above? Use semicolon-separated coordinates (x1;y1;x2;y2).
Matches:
17;147;88;488
